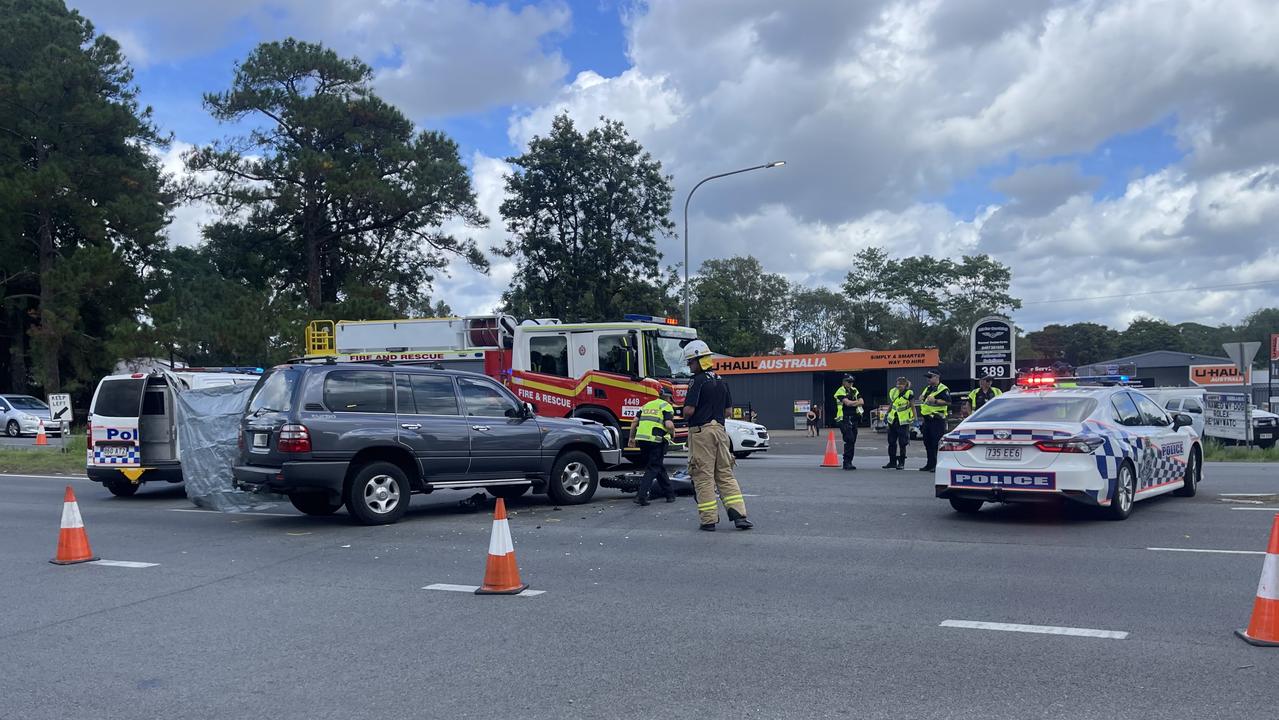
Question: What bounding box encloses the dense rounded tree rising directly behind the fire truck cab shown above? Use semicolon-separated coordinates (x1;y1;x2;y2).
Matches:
494;115;674;321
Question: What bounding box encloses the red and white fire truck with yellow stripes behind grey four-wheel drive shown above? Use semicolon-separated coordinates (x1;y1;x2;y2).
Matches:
304;315;697;444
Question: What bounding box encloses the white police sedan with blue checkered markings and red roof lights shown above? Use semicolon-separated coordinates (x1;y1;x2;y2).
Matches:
934;377;1204;520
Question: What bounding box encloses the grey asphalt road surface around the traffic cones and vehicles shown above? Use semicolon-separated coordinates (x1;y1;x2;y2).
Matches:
0;452;1279;720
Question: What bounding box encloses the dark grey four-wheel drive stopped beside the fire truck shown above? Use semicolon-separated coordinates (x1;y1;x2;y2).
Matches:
234;363;622;524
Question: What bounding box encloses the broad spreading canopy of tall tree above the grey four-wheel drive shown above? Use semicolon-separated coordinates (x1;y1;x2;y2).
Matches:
187;38;489;311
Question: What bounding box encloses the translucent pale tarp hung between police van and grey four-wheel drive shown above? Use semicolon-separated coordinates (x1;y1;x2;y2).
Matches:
173;385;283;513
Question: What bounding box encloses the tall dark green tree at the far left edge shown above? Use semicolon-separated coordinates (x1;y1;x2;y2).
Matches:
0;0;170;393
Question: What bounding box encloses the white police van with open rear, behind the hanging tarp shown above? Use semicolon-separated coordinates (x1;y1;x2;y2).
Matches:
84;368;261;497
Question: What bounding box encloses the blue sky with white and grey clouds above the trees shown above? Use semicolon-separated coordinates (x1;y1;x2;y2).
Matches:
72;0;1279;327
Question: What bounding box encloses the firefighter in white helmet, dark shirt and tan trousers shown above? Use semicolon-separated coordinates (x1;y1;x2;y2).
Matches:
683;340;755;531
